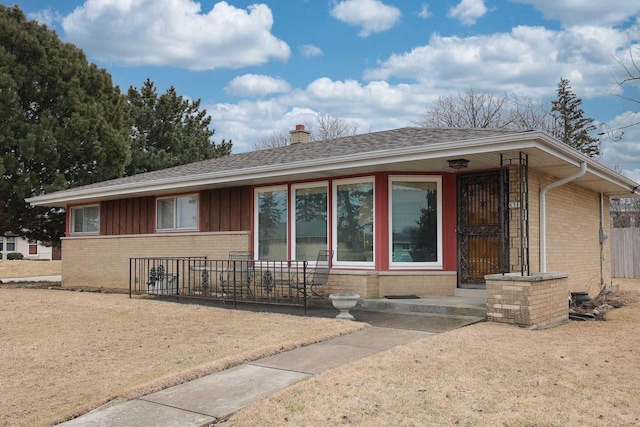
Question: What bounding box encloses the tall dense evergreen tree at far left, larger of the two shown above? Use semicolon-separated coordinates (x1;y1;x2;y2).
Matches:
0;5;130;244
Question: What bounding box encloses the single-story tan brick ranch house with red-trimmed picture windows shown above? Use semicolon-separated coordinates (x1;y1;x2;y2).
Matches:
29;126;638;298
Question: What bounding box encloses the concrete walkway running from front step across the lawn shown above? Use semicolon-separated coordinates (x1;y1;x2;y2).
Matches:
61;311;480;427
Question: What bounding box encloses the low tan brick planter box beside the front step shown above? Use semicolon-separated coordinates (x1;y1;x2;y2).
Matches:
487;273;569;328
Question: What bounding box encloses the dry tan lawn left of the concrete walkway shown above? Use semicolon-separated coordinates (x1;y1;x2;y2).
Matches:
0;290;366;426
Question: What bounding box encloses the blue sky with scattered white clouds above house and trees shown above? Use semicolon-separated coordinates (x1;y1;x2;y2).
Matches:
1;0;640;180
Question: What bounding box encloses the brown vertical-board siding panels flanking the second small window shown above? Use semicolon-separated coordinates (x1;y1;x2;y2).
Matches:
100;186;252;236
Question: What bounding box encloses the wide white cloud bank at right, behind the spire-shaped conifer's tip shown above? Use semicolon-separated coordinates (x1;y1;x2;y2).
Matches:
365;26;627;97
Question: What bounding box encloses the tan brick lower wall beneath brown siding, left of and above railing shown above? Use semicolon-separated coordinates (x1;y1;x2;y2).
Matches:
62;231;250;289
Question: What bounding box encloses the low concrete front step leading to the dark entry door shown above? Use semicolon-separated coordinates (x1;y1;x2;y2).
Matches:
363;296;487;318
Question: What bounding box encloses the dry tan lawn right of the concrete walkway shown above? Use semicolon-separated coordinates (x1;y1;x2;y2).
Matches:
230;280;640;426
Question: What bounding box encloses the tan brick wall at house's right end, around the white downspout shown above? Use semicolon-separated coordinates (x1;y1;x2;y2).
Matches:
529;170;611;296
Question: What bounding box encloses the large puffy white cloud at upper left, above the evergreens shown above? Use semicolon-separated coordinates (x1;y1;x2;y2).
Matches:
62;0;290;70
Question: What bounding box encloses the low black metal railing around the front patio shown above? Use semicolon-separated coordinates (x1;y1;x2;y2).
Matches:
129;257;308;313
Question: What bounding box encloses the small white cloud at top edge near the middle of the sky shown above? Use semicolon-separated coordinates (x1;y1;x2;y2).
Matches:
331;0;402;37
